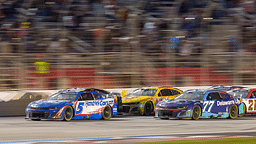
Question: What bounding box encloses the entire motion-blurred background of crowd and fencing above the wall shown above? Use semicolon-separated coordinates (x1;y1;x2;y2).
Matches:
0;0;256;90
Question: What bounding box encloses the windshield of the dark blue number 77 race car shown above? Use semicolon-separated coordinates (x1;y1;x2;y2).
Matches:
175;92;205;100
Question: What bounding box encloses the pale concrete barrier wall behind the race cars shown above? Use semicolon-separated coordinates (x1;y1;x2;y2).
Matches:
0;85;256;116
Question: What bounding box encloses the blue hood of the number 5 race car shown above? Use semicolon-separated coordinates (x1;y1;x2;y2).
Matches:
28;100;72;108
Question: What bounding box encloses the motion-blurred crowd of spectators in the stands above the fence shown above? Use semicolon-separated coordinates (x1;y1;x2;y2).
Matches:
0;0;256;57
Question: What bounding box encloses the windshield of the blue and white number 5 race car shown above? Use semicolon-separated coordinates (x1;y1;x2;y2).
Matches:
46;93;77;101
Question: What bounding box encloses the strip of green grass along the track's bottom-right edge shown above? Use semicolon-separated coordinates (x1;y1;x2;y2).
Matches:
130;137;256;144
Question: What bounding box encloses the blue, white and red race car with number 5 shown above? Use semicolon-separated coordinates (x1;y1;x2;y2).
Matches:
26;89;117;121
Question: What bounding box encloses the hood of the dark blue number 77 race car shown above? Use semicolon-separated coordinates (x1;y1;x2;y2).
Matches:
157;100;195;108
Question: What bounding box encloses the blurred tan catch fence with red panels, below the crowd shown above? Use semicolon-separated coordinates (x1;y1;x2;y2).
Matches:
0;52;256;90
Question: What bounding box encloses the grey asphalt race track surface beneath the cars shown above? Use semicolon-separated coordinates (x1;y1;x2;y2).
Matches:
0;115;256;143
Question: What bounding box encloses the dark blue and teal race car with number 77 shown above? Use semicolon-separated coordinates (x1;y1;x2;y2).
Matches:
155;90;244;120
